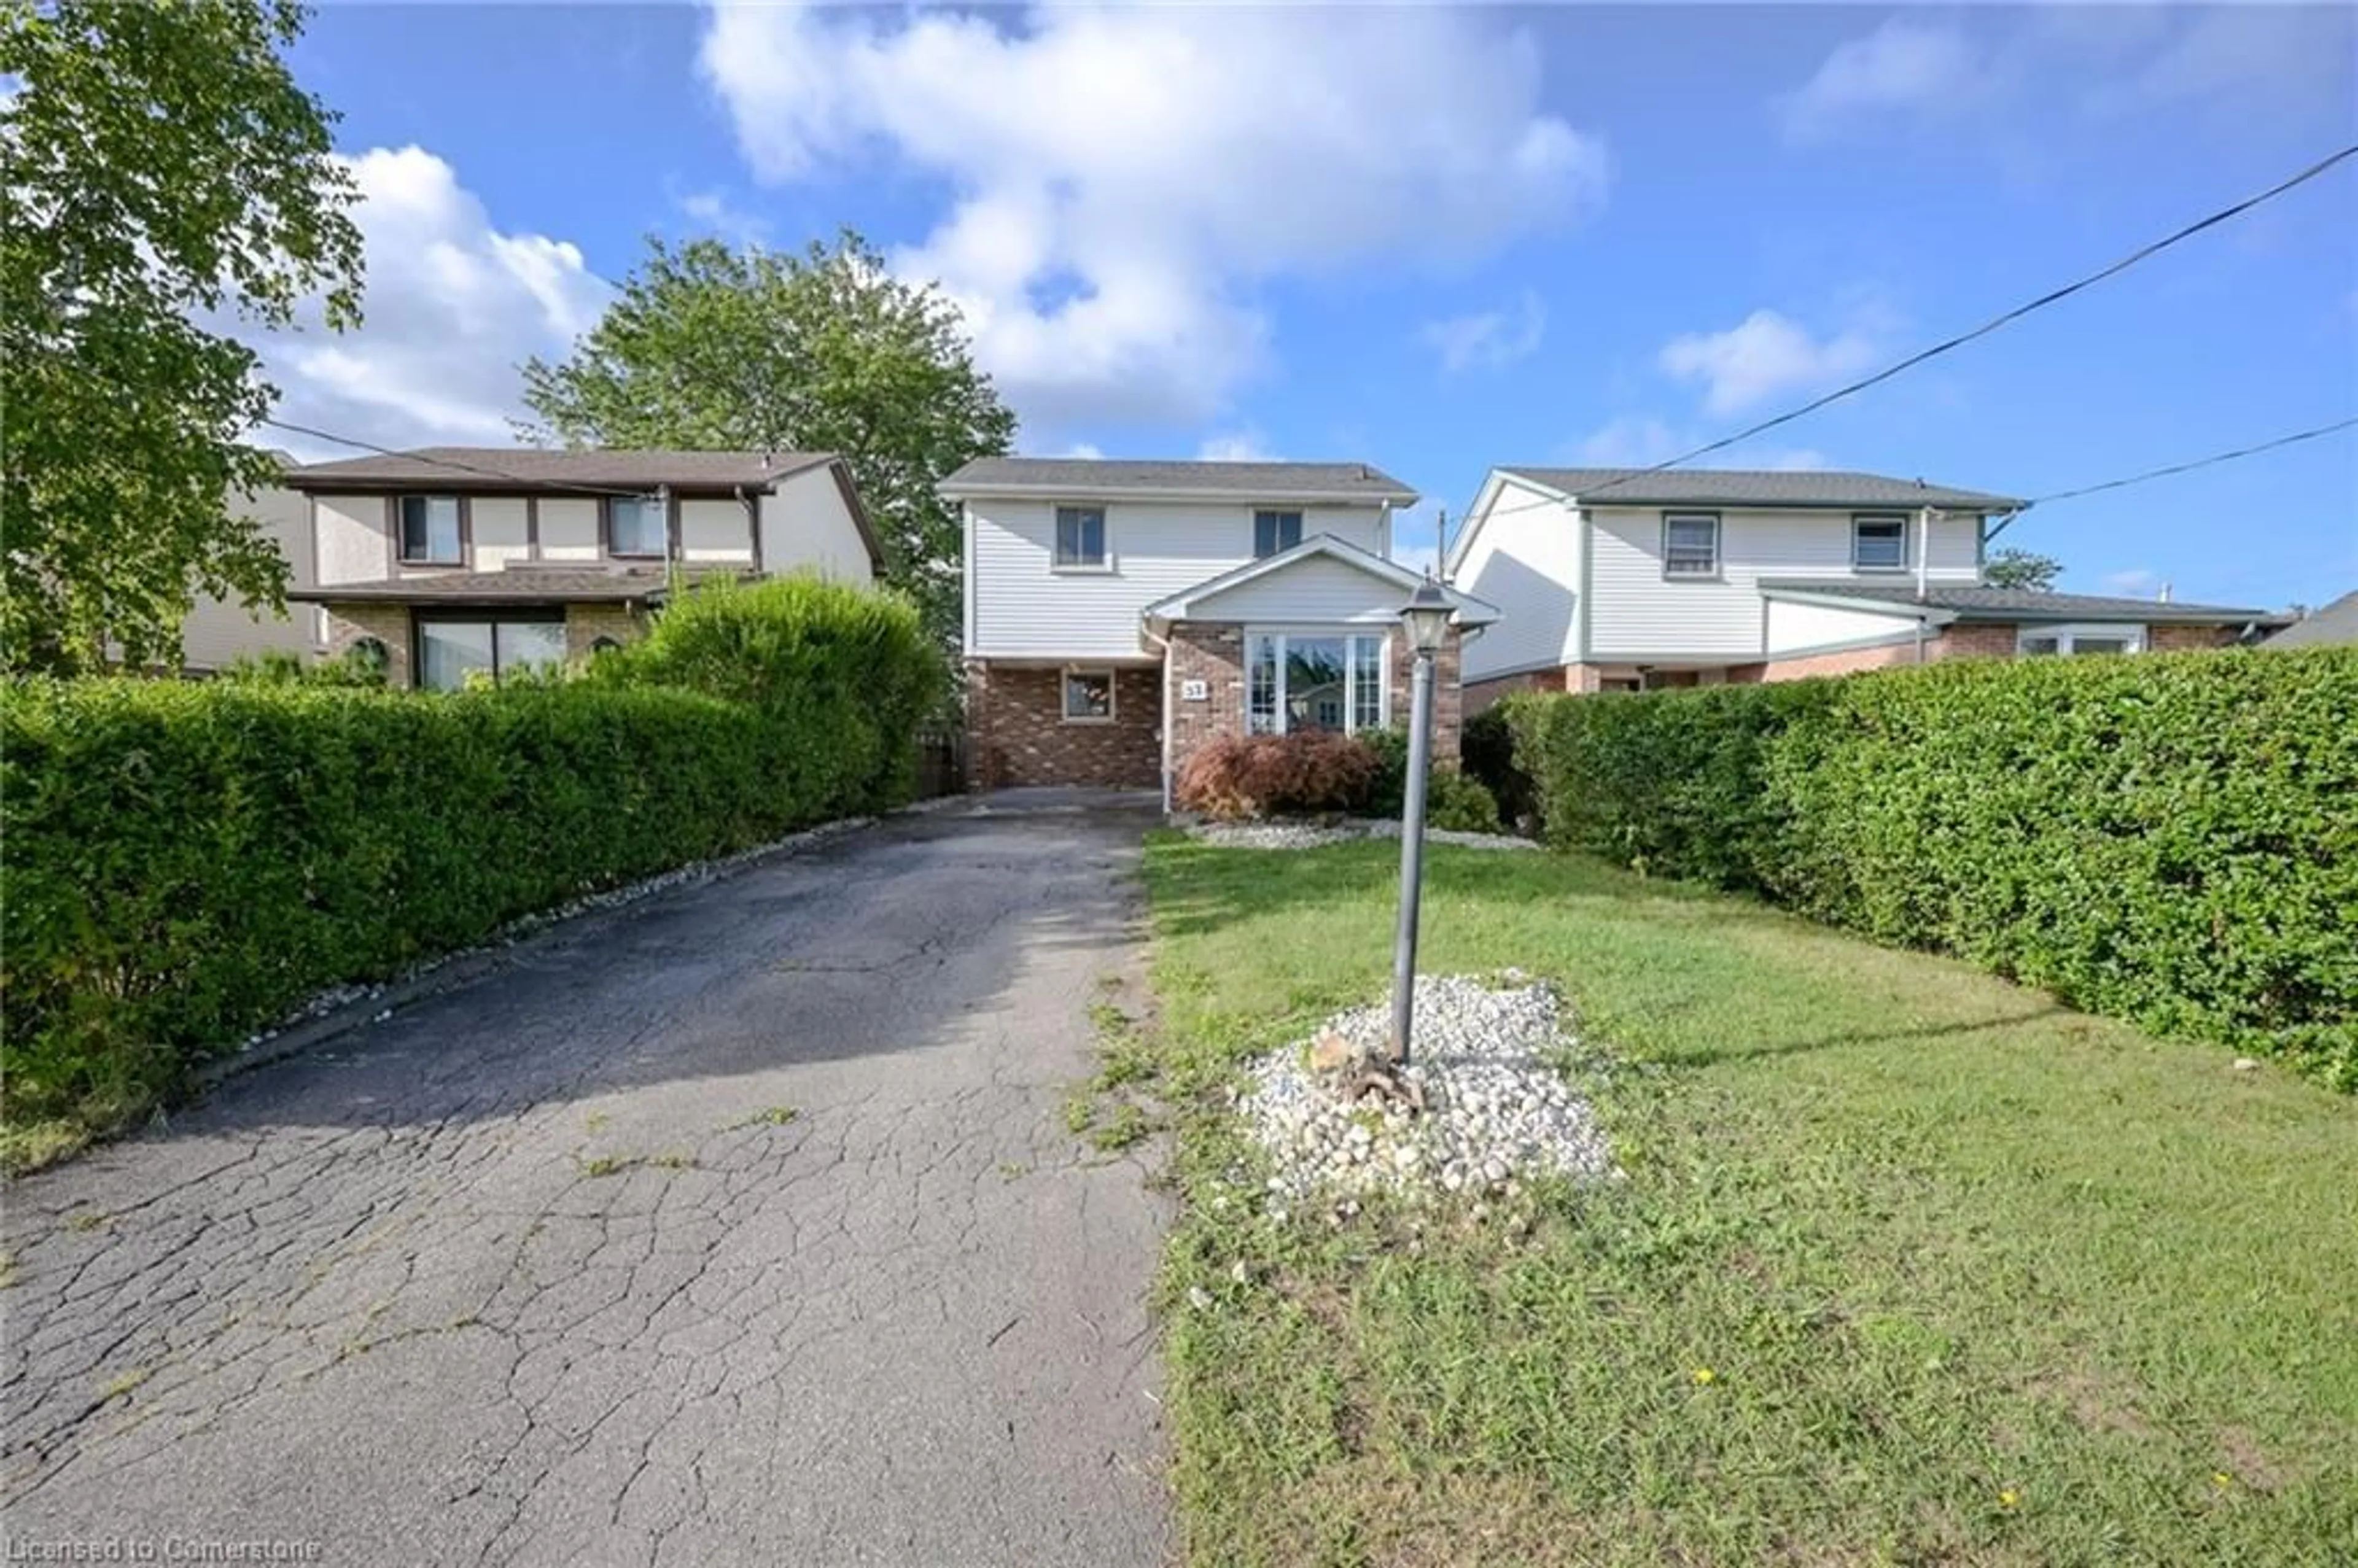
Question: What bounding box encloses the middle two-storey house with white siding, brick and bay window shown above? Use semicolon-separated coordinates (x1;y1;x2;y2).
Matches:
941;457;1497;797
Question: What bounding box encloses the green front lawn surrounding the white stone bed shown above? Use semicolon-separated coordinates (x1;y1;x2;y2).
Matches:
1146;835;2358;1568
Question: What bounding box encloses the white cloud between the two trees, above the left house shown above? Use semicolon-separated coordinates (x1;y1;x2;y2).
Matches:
250;146;613;457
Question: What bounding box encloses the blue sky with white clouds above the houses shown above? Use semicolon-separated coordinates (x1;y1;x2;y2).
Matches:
269;5;2358;604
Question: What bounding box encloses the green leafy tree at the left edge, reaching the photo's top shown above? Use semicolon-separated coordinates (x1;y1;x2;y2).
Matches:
0;0;361;670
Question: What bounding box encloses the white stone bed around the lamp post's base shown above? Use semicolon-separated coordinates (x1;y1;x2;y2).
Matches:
1238;971;1613;1217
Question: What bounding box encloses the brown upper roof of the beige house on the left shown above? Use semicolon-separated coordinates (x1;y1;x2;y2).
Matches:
286;446;835;491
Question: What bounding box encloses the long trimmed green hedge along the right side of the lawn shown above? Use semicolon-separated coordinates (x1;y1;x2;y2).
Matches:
1507;648;2358;1089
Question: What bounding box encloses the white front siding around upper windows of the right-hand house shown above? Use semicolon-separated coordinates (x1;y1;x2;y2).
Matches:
1584;507;1981;655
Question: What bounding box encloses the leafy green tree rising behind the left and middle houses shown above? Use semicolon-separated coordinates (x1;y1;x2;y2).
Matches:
523;229;1016;642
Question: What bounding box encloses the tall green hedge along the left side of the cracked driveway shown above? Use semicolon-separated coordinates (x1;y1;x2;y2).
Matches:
0;568;941;1146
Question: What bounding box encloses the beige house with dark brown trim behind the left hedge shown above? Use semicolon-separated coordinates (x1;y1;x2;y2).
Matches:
286;446;884;688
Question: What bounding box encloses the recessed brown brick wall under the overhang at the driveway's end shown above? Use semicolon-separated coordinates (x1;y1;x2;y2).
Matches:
967;660;1162;790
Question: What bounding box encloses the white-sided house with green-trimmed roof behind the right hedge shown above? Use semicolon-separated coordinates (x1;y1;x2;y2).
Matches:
1448;467;2285;710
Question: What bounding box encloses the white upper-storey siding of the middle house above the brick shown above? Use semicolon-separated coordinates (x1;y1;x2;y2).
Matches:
967;500;1398;660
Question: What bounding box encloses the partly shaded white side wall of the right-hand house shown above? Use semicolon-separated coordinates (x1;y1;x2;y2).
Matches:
1455;479;1580;681
